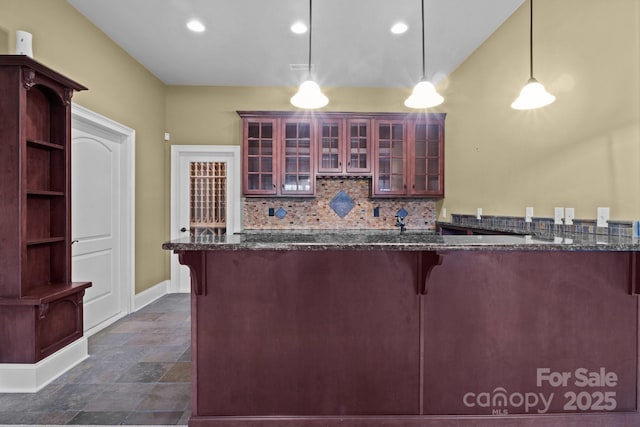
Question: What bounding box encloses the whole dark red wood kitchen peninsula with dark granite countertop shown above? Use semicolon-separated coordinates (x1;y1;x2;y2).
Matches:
163;230;640;427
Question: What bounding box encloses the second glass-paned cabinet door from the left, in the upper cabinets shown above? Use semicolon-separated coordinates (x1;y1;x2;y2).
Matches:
281;120;314;194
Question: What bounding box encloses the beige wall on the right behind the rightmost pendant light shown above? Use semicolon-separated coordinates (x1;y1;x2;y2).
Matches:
443;0;640;220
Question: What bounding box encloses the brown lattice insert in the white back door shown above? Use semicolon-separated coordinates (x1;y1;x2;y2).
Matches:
189;162;227;237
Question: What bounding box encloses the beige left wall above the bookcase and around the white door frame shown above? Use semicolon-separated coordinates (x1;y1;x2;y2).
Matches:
0;0;169;292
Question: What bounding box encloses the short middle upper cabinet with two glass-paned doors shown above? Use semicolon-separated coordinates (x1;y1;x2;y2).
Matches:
317;117;372;176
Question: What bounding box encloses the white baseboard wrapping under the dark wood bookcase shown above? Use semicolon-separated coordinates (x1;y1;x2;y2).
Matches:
0;337;89;393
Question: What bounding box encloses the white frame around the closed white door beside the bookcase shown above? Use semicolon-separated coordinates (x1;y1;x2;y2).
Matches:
71;104;136;337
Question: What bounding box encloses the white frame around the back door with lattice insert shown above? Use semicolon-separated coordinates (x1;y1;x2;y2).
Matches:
169;145;242;293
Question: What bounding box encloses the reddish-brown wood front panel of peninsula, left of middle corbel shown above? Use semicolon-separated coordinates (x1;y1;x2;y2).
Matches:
188;251;420;416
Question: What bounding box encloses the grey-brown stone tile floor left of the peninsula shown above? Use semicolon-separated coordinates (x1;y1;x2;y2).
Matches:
0;294;191;425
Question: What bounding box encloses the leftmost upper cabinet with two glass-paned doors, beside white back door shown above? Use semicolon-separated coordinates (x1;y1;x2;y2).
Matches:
238;112;315;196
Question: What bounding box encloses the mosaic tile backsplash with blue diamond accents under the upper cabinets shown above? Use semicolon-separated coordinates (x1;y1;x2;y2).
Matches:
242;178;437;230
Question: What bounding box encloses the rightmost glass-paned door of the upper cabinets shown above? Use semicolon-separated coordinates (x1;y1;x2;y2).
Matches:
412;122;443;194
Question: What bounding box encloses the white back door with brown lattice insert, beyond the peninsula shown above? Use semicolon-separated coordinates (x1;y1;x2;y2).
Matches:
171;145;241;292
